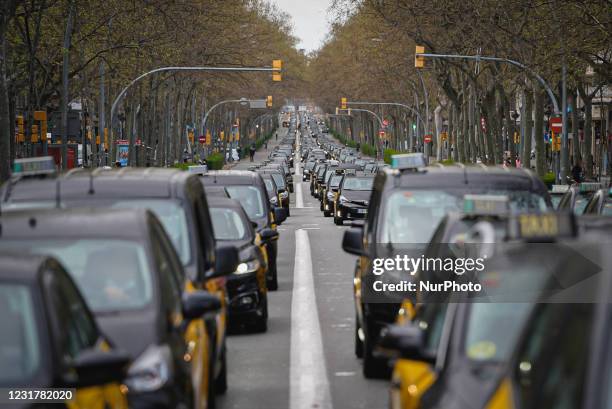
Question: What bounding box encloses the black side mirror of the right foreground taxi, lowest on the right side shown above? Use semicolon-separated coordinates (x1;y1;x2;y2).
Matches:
376;324;436;364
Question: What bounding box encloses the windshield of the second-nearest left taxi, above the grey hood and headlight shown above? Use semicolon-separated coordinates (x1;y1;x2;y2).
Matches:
0;237;153;313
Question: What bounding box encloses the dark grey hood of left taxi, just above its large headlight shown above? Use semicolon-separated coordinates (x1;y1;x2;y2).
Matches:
96;308;160;359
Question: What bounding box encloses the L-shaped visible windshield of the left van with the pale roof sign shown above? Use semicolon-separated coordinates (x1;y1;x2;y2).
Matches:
111;200;191;266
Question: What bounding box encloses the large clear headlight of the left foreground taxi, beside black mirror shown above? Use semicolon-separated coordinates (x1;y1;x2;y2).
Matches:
125;345;172;392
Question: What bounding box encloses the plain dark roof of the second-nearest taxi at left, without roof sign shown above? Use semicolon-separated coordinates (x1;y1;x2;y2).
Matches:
0;208;155;240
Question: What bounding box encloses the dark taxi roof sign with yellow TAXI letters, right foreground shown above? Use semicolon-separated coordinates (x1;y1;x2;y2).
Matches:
508;212;578;241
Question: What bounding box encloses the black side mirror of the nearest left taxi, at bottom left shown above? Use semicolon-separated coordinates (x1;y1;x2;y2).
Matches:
66;348;130;388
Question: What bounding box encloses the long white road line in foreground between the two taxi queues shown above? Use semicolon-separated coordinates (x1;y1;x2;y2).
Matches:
289;229;332;409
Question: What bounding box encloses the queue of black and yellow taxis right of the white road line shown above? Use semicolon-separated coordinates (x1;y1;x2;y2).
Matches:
302;117;612;409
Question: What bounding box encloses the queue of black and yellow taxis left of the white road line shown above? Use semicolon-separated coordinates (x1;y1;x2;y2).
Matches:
0;115;293;409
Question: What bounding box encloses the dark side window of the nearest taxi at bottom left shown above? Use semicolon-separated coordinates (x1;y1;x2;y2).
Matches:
48;273;98;359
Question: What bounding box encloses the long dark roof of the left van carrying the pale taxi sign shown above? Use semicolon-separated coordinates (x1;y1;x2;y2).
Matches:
2;168;197;201
